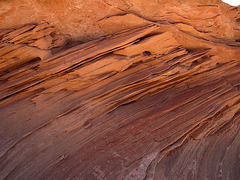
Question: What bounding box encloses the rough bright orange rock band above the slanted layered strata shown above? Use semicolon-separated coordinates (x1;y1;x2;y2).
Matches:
0;0;240;41
